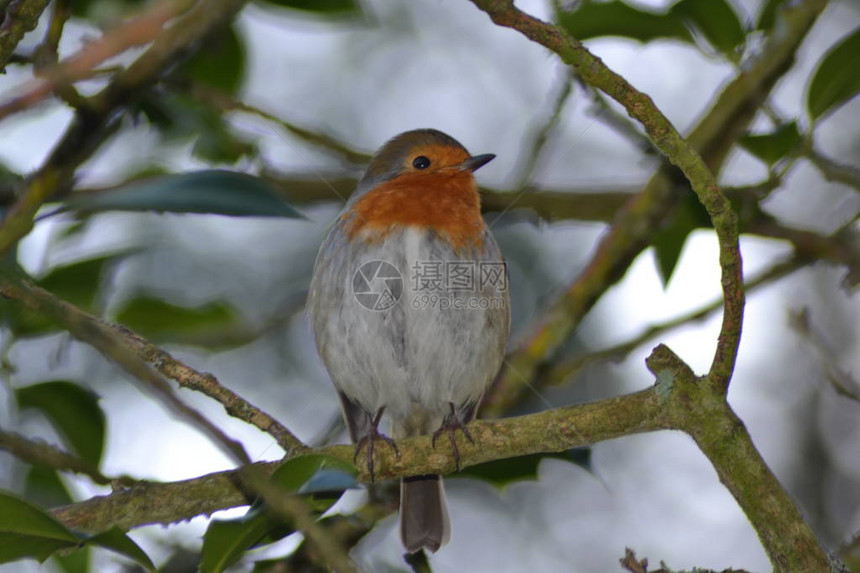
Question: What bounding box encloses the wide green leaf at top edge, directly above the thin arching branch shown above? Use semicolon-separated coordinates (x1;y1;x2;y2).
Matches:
557;0;693;43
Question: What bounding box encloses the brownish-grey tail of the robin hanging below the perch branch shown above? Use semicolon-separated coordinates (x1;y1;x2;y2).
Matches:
400;475;451;553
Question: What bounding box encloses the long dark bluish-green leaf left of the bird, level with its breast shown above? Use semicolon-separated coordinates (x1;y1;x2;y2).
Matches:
56;169;304;218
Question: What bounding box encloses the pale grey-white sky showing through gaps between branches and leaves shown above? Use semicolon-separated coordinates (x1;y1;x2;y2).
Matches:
0;0;860;573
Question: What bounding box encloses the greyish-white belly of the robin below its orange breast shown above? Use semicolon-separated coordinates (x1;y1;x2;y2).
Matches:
309;225;509;423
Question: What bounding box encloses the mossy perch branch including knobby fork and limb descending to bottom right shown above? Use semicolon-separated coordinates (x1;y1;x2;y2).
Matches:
45;345;830;573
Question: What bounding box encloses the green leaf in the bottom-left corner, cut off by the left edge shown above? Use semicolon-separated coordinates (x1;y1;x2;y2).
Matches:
0;491;78;563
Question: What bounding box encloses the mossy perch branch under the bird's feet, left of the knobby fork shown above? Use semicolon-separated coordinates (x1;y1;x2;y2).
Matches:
54;390;668;532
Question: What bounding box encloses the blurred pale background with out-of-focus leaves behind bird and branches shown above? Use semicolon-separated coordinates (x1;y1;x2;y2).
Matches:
0;0;860;573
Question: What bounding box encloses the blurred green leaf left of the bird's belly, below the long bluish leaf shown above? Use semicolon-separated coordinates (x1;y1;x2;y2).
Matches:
116;296;241;341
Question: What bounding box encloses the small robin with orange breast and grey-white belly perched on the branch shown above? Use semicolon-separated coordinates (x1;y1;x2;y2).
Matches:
308;129;510;553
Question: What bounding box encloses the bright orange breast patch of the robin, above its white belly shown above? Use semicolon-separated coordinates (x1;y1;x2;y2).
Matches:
343;171;484;250
